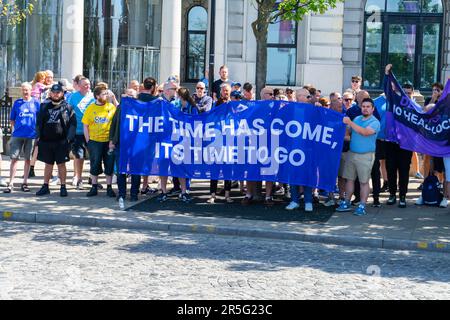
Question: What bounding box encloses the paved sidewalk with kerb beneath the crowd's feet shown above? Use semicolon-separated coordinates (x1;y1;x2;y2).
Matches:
0;160;450;252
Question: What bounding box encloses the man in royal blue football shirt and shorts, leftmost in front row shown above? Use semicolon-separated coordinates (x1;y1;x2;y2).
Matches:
4;83;40;193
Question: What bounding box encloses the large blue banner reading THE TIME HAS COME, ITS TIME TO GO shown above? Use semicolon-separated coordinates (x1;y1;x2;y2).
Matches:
119;98;345;191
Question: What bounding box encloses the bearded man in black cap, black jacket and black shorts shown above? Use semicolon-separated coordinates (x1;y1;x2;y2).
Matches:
36;84;77;197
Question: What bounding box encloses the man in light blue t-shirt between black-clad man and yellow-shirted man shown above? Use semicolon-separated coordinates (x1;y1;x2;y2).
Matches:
68;78;95;189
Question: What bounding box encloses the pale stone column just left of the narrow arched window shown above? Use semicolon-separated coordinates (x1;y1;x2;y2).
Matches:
159;0;181;82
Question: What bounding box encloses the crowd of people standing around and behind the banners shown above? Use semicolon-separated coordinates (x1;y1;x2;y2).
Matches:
0;65;450;216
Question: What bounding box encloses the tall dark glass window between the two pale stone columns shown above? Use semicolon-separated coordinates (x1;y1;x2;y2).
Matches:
84;0;162;86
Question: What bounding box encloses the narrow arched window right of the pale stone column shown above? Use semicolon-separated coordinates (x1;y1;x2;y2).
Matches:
186;6;208;82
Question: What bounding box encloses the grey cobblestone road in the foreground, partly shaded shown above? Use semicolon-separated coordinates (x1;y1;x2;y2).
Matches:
0;223;450;299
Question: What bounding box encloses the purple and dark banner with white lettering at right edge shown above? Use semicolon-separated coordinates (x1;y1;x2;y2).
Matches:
384;74;450;157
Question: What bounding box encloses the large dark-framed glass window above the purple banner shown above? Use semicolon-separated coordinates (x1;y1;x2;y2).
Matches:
363;0;444;90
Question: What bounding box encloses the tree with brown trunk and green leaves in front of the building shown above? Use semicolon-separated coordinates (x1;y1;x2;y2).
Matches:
252;0;343;95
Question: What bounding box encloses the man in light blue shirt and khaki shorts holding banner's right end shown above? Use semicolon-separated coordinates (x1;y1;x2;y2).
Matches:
337;98;380;216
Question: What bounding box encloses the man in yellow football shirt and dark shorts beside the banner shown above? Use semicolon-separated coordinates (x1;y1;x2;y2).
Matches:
81;86;116;198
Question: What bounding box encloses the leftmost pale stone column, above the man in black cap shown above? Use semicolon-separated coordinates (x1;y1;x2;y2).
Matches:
61;0;84;81
